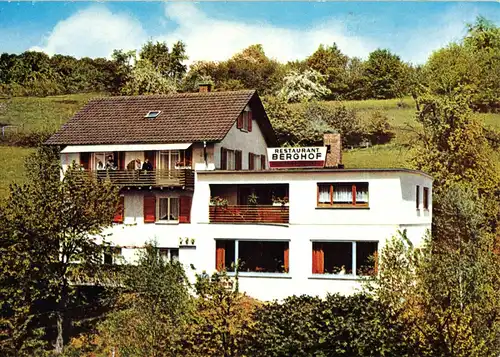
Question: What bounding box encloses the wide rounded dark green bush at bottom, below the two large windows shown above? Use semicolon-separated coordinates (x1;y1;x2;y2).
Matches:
247;294;410;357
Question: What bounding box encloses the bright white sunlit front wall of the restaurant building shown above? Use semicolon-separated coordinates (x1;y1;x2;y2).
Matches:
110;170;432;300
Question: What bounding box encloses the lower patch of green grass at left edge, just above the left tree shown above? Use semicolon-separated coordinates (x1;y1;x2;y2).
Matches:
0;146;35;198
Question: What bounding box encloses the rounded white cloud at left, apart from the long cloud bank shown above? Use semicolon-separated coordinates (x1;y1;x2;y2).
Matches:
32;5;147;57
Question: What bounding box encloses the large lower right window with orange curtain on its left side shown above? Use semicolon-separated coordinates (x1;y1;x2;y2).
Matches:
312;242;378;276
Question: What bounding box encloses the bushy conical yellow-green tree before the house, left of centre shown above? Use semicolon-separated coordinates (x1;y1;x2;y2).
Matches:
98;242;192;357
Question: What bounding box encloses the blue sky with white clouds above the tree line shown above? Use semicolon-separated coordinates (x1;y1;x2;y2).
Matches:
0;1;500;64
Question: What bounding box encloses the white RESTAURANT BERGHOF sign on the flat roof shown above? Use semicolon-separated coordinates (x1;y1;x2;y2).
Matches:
267;146;326;168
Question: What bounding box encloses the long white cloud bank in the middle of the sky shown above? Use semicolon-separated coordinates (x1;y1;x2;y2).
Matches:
157;2;377;62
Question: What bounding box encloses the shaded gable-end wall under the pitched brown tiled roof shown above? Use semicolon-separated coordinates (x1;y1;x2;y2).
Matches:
214;108;267;170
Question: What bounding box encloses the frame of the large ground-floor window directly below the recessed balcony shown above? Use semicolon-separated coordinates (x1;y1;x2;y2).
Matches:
214;238;290;277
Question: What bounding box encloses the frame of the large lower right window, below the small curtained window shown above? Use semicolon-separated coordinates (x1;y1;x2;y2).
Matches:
311;240;380;279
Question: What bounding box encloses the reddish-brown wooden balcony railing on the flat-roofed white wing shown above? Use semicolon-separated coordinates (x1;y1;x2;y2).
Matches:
210;205;289;223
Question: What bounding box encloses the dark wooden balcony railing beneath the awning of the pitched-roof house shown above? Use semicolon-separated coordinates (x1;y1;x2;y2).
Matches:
90;169;194;188
